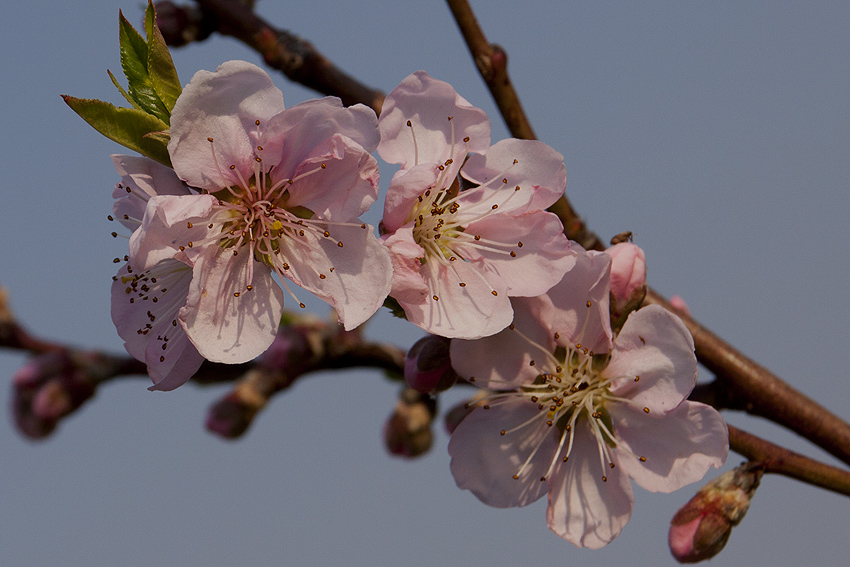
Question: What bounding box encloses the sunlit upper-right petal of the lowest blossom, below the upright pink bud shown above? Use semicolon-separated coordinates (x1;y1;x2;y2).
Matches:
604;305;697;412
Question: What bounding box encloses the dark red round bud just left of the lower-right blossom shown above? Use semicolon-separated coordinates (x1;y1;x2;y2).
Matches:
404;335;458;393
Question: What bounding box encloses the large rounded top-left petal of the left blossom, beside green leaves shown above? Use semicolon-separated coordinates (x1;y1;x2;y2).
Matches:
168;61;284;192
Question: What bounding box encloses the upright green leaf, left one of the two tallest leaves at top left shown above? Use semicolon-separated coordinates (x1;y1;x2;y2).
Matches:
118;7;170;125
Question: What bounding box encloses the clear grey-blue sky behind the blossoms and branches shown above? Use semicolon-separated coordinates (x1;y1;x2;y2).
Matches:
0;0;850;567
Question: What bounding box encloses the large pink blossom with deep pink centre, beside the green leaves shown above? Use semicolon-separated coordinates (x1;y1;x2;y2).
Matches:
123;61;392;363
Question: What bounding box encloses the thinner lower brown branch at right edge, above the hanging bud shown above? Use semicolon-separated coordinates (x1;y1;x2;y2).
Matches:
729;425;850;496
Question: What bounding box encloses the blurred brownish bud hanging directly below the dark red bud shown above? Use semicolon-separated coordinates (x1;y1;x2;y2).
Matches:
384;388;437;458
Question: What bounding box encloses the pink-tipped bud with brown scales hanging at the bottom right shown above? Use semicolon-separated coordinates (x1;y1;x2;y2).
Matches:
668;463;763;563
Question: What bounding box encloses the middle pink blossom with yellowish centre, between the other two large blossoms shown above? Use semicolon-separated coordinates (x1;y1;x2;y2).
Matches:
378;71;575;338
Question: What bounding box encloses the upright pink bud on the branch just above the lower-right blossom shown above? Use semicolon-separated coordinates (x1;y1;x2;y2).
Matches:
607;242;646;329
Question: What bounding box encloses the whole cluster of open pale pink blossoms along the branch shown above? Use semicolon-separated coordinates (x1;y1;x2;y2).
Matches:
112;61;728;547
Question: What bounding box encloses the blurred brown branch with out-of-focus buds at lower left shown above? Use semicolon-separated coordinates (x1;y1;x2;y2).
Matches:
0;287;405;439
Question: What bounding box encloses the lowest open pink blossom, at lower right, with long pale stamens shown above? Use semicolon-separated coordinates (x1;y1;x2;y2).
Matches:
449;247;728;548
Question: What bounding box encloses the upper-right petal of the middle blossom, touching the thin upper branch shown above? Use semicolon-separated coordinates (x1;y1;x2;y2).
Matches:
461;138;567;215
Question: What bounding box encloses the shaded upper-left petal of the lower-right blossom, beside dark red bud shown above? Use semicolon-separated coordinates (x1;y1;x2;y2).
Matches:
450;296;555;390
